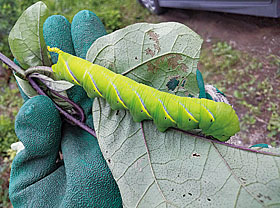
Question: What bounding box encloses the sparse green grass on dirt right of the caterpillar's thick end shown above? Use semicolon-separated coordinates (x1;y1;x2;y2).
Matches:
200;42;280;146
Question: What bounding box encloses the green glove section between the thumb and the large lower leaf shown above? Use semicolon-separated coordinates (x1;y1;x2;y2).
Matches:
61;123;122;207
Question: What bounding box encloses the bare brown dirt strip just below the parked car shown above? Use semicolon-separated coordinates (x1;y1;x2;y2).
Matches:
161;9;280;56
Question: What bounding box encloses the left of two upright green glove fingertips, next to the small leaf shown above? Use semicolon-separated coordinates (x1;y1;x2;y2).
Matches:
43;15;75;64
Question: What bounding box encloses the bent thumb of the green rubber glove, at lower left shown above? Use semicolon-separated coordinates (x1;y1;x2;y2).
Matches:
10;96;61;194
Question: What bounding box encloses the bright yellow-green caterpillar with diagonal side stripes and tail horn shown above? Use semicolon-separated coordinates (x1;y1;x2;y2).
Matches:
48;47;239;141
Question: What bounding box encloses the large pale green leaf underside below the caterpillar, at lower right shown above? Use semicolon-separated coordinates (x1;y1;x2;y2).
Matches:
93;99;280;208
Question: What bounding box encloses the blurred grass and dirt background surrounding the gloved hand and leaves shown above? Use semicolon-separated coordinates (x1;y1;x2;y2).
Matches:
0;0;280;207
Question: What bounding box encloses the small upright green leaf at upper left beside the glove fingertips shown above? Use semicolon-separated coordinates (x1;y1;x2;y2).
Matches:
9;1;51;69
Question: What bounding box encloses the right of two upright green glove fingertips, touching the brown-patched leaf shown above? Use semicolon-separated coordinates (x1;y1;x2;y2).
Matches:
71;10;107;59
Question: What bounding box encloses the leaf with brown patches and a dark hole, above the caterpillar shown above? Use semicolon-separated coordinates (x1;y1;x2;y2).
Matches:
87;22;202;97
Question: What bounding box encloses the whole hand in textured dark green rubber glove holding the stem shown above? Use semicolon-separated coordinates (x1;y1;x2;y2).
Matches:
9;11;122;208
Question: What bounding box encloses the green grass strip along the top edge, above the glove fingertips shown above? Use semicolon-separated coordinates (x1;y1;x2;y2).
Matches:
44;0;158;33
